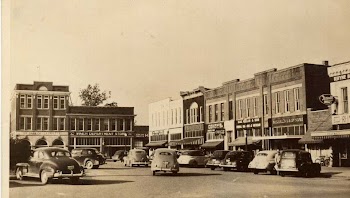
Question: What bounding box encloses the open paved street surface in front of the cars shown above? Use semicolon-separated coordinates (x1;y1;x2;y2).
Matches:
10;162;350;198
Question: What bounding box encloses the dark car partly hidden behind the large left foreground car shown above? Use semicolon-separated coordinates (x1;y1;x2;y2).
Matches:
72;148;106;169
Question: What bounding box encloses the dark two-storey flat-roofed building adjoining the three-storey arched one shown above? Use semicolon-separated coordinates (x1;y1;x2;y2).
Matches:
67;106;135;156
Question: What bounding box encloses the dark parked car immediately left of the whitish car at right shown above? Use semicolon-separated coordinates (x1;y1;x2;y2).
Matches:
220;151;252;171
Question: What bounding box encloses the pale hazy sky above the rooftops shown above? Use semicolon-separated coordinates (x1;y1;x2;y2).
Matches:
2;0;350;131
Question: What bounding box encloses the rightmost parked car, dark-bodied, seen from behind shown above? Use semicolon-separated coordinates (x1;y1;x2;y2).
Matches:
275;149;321;177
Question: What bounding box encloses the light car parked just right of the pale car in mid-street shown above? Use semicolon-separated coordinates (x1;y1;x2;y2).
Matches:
177;150;207;167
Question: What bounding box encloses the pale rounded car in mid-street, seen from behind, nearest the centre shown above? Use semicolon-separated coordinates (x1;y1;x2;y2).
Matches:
151;148;180;175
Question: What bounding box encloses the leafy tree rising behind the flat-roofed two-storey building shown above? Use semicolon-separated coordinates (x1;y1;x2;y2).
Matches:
79;83;111;106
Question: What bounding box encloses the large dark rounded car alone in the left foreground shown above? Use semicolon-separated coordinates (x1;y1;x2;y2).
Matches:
16;147;84;184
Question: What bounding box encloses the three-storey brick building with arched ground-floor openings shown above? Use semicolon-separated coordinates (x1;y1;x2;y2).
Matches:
10;81;70;148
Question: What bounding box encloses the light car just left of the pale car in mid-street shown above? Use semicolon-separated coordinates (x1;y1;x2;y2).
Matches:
124;149;149;167
